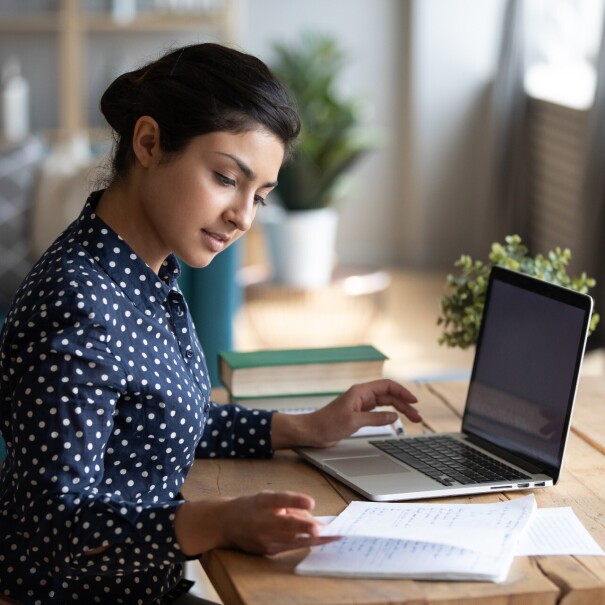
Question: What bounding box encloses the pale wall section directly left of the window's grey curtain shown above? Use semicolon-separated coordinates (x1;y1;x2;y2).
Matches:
398;0;504;266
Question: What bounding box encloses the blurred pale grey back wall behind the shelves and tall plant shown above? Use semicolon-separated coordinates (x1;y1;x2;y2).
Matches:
0;0;505;267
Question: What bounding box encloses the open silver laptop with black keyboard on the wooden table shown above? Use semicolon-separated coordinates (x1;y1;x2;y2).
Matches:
296;267;593;501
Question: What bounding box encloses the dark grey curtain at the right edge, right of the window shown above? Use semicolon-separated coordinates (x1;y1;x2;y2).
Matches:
582;10;605;348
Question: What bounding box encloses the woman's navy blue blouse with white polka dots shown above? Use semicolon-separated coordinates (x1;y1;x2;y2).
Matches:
0;192;272;605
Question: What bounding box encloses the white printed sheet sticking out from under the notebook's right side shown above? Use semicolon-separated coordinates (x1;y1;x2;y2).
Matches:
515;506;605;556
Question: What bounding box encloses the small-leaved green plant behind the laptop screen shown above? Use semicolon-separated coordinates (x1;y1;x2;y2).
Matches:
437;235;599;349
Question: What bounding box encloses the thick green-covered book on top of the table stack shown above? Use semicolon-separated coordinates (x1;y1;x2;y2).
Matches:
219;345;387;398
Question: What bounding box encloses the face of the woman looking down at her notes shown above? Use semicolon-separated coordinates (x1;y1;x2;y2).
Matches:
134;129;284;270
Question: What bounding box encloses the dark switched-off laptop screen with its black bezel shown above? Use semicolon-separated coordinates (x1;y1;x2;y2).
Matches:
463;268;592;480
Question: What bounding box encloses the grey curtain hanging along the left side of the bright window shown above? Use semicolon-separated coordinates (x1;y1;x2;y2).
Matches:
479;0;527;251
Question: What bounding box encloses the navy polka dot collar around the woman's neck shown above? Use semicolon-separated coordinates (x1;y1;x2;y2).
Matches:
74;191;181;315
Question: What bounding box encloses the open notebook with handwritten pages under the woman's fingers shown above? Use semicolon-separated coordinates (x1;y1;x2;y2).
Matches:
296;495;536;582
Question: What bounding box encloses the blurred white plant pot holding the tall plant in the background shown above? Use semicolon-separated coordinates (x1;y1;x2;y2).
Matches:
259;206;338;288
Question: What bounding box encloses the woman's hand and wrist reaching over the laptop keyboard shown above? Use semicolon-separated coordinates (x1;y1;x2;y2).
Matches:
272;378;422;449
